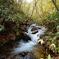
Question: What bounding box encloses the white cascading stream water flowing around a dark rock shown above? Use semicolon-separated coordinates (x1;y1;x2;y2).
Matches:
12;24;46;54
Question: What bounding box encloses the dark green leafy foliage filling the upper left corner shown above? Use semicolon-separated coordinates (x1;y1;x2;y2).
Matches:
0;0;26;21
